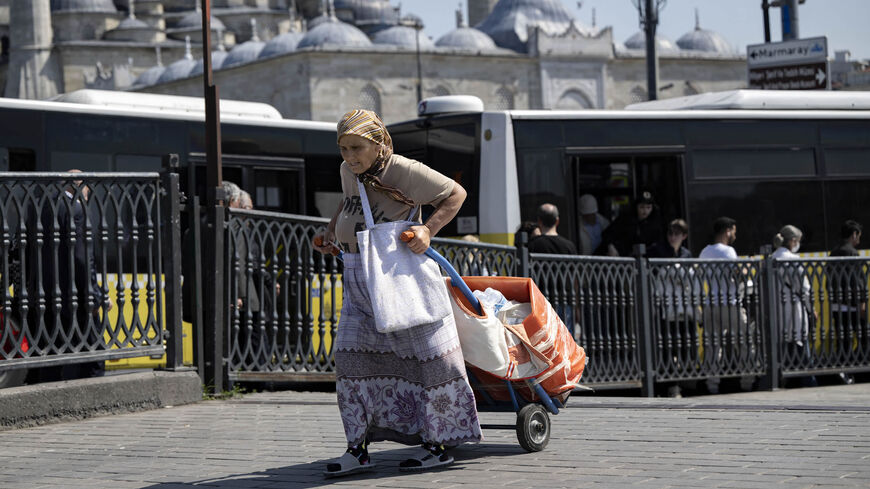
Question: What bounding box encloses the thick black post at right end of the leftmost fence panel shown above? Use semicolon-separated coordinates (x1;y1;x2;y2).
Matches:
160;154;184;370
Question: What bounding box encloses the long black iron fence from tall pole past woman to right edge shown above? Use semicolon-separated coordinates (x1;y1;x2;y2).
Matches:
216;210;870;395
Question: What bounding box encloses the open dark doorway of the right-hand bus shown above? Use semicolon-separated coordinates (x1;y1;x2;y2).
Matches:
569;152;686;252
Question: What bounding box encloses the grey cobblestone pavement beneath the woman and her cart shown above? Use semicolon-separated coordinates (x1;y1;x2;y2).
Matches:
0;384;870;489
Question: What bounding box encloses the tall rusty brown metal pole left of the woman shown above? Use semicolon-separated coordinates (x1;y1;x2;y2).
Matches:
202;0;225;393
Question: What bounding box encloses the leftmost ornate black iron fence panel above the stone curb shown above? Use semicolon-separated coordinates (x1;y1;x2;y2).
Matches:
0;173;181;382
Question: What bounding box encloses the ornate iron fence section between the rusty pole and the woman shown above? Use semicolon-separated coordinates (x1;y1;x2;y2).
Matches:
225;209;342;381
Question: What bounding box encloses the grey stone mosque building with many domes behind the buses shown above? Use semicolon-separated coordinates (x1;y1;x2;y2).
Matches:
0;0;746;122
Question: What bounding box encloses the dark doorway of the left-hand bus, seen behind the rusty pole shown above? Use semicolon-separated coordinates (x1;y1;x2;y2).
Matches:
185;153;306;214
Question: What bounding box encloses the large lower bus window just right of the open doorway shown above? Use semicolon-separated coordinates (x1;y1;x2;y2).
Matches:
689;180;826;255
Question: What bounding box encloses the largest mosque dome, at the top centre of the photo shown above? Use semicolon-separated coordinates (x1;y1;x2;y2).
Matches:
475;0;573;52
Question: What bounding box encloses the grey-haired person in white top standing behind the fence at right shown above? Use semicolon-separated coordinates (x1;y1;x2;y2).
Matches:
771;225;816;374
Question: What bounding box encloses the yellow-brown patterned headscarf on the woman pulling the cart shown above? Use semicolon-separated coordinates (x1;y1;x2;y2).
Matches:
336;109;415;207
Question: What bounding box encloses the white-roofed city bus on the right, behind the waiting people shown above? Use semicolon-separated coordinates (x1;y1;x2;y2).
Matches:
389;90;870;255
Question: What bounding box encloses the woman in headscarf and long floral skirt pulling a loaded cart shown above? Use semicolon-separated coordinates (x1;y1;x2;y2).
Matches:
313;110;481;477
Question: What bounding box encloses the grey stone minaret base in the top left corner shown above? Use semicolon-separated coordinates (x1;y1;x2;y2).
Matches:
4;0;63;99
